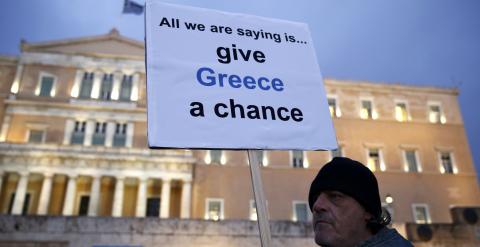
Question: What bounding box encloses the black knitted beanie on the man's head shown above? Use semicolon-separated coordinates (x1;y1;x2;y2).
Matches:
308;157;382;217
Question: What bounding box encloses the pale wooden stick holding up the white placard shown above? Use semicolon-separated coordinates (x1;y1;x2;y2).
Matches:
247;150;271;247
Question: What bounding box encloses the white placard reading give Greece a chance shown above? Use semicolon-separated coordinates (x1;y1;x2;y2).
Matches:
145;1;337;150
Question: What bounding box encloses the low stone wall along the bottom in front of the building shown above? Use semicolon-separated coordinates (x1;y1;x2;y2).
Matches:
0;215;480;247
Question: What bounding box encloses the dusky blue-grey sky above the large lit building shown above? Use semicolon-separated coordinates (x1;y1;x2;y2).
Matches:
0;0;480;179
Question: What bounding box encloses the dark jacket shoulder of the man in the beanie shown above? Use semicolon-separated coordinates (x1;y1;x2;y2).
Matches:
355;227;413;247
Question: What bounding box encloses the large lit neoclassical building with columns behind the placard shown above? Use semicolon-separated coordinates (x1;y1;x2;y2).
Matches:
0;29;480;233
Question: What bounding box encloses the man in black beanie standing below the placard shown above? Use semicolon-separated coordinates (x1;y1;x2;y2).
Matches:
308;157;413;247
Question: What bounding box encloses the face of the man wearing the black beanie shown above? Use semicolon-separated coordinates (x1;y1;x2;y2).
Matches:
313;191;371;246
